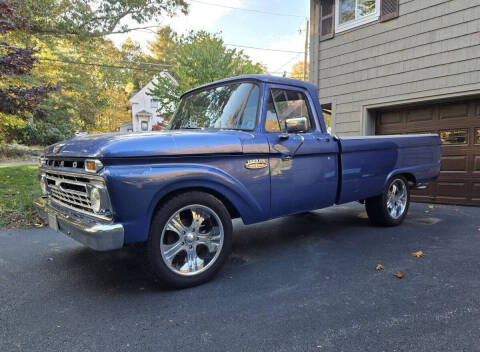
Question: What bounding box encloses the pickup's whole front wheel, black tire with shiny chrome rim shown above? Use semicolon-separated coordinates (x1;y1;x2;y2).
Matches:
148;191;232;288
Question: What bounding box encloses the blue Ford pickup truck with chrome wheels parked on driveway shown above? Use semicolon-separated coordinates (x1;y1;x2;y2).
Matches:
36;75;441;287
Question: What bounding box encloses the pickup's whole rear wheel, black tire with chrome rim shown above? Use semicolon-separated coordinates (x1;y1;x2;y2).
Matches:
365;176;410;226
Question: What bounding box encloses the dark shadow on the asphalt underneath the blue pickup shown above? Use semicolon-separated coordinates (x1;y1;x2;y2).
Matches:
56;207;370;294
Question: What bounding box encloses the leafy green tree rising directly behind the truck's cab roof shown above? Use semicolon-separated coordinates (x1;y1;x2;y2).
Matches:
150;31;265;115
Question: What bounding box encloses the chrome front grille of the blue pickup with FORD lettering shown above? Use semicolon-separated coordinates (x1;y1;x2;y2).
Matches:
40;167;112;220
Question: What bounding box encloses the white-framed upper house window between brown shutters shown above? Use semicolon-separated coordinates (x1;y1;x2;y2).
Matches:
335;0;380;32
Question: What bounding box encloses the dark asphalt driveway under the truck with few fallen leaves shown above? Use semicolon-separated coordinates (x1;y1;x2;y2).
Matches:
0;204;480;352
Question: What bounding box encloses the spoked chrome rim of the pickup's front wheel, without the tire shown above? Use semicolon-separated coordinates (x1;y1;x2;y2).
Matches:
160;204;224;276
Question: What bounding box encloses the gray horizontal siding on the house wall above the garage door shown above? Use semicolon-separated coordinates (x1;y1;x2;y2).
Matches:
310;0;480;135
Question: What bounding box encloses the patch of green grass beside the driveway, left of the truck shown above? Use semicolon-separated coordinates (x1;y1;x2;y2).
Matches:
0;165;42;228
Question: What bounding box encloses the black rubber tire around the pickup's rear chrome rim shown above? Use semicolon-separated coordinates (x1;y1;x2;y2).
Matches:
365;175;410;226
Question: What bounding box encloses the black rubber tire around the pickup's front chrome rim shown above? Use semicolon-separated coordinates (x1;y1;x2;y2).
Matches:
147;191;232;288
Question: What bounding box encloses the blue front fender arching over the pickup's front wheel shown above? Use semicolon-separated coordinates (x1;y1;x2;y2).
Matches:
105;163;266;243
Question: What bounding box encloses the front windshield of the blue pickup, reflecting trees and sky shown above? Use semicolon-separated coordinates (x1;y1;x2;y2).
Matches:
168;83;260;130
